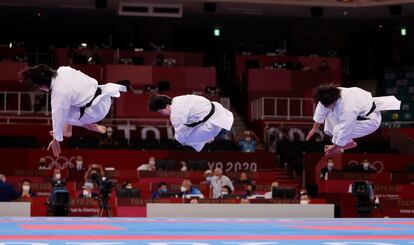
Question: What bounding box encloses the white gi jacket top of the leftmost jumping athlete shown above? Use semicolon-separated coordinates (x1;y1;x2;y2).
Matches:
50;66;98;141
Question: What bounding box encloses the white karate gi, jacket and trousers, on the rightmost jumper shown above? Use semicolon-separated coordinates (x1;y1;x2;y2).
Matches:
313;87;401;146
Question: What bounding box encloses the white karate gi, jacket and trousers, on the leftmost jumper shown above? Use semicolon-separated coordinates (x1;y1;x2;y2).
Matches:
50;66;126;141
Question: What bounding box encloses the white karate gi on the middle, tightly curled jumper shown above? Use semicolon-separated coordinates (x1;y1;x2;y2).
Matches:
170;95;234;151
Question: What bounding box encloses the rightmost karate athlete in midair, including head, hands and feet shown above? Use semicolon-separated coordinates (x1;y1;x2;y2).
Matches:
306;84;401;155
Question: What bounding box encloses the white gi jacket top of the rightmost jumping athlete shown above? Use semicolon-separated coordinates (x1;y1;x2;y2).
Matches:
313;87;374;146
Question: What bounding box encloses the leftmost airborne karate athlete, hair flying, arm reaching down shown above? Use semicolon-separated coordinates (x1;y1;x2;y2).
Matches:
20;64;126;157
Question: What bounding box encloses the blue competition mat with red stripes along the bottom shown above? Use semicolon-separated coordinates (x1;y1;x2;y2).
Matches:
0;218;414;245
